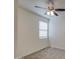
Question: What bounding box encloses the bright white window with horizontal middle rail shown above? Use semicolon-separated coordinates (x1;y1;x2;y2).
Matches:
39;21;48;39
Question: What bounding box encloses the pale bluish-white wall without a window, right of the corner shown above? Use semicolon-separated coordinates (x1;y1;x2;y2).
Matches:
49;16;65;49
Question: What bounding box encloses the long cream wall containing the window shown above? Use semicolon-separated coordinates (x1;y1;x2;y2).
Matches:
15;8;49;58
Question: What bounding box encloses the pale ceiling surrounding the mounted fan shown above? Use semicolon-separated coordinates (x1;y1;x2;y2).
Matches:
18;0;65;19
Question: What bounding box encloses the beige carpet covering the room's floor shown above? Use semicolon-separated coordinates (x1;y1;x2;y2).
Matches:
24;48;65;59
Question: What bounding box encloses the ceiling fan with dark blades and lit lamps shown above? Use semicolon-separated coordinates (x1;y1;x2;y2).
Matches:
34;0;65;16
